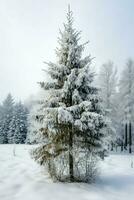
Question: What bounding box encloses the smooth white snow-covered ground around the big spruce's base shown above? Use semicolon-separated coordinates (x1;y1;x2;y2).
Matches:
0;145;134;200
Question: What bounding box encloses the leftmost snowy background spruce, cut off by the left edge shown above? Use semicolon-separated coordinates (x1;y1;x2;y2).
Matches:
0;94;14;144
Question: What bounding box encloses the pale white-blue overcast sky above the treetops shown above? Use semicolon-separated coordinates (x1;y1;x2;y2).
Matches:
0;0;134;101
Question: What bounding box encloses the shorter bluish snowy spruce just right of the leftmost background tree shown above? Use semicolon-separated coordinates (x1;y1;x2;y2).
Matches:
8;102;28;144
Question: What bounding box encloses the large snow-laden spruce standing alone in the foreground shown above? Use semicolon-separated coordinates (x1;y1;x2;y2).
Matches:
33;9;105;182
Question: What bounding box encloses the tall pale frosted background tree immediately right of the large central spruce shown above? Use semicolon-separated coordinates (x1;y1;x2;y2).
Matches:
98;61;118;149
